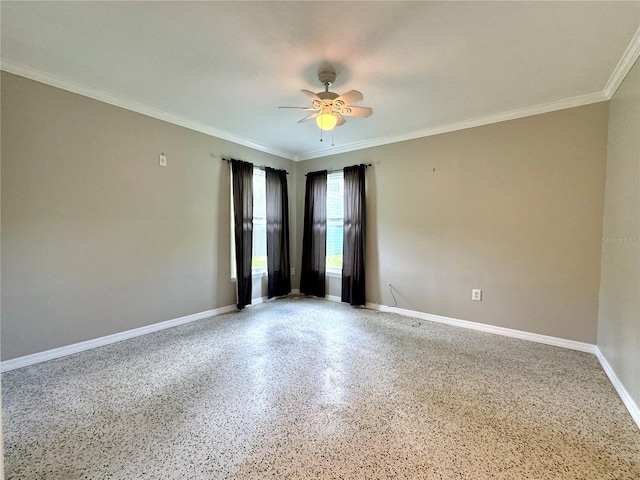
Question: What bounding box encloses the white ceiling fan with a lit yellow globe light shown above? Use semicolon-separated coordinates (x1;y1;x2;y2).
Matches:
279;69;373;130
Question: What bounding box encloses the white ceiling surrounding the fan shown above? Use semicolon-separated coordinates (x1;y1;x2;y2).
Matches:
1;1;640;159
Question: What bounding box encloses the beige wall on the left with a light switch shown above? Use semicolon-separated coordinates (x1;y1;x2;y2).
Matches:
1;72;296;359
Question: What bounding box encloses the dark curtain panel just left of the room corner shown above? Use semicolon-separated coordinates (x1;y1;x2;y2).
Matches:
265;167;291;298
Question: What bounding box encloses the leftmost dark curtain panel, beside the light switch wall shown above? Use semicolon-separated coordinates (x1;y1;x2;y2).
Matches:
230;160;253;310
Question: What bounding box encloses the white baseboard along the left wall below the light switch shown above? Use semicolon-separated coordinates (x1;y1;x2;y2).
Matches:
0;305;237;372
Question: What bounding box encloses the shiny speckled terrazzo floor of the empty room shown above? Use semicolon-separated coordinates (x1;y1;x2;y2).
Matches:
2;298;640;480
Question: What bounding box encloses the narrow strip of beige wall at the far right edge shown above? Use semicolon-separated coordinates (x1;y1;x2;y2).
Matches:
598;57;640;406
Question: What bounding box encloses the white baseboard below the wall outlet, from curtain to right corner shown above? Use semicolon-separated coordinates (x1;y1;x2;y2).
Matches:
366;303;596;353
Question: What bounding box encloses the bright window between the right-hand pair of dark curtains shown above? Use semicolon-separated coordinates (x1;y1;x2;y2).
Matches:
327;170;344;275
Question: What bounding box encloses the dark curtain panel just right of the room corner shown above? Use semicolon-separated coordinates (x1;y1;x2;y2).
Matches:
300;170;327;297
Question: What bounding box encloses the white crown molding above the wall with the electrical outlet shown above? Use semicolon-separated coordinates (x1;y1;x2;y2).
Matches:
293;92;609;161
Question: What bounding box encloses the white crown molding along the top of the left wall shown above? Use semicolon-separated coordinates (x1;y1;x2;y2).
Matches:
0;59;293;160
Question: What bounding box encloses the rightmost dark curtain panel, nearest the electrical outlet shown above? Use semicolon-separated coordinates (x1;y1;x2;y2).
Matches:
342;165;366;305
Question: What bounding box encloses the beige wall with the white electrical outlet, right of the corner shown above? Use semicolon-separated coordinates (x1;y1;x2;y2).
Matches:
296;103;608;344
